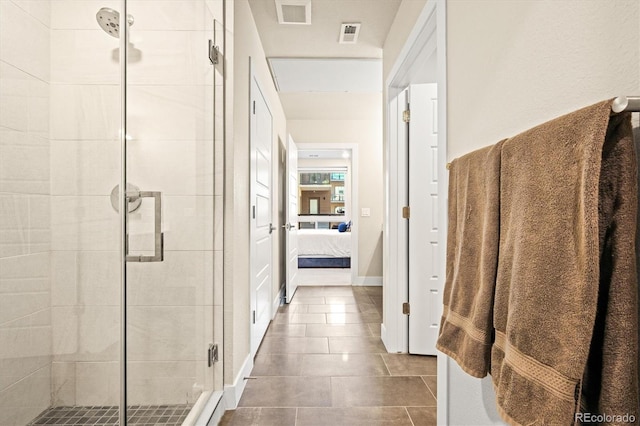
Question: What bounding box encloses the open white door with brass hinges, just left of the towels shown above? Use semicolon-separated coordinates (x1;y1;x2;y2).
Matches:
409;84;441;355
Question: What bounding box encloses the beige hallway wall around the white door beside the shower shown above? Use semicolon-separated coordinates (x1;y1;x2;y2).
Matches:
224;0;286;384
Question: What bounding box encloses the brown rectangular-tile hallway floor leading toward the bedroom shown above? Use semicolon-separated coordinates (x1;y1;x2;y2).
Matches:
220;286;437;426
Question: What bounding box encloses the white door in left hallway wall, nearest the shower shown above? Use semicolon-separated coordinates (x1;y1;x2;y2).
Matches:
249;76;274;356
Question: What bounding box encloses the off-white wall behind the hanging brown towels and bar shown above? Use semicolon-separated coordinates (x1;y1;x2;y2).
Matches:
447;0;640;425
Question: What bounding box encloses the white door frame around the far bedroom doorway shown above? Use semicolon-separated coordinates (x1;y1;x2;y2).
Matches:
296;142;364;285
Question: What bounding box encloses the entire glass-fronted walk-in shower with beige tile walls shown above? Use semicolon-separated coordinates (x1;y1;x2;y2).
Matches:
0;0;223;426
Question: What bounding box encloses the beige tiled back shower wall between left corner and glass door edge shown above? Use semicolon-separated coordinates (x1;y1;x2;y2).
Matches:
50;0;120;406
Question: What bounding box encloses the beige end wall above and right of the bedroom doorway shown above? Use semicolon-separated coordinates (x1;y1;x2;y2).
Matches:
287;119;383;277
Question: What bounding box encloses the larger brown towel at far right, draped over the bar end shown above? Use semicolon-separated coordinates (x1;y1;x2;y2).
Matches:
491;101;638;425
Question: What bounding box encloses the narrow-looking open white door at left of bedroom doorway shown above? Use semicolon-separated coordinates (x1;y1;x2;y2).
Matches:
284;136;298;303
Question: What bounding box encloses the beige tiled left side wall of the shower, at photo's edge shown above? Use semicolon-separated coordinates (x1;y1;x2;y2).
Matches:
0;0;51;425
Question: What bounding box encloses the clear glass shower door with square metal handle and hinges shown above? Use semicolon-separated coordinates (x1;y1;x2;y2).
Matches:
120;0;222;424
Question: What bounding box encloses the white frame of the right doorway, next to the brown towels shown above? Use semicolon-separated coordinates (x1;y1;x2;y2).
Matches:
381;0;449;425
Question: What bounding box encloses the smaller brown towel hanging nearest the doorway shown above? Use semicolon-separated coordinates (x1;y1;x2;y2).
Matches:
436;142;502;377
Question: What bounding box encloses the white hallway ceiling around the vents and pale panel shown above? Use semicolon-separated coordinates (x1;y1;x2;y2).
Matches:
249;0;401;120
